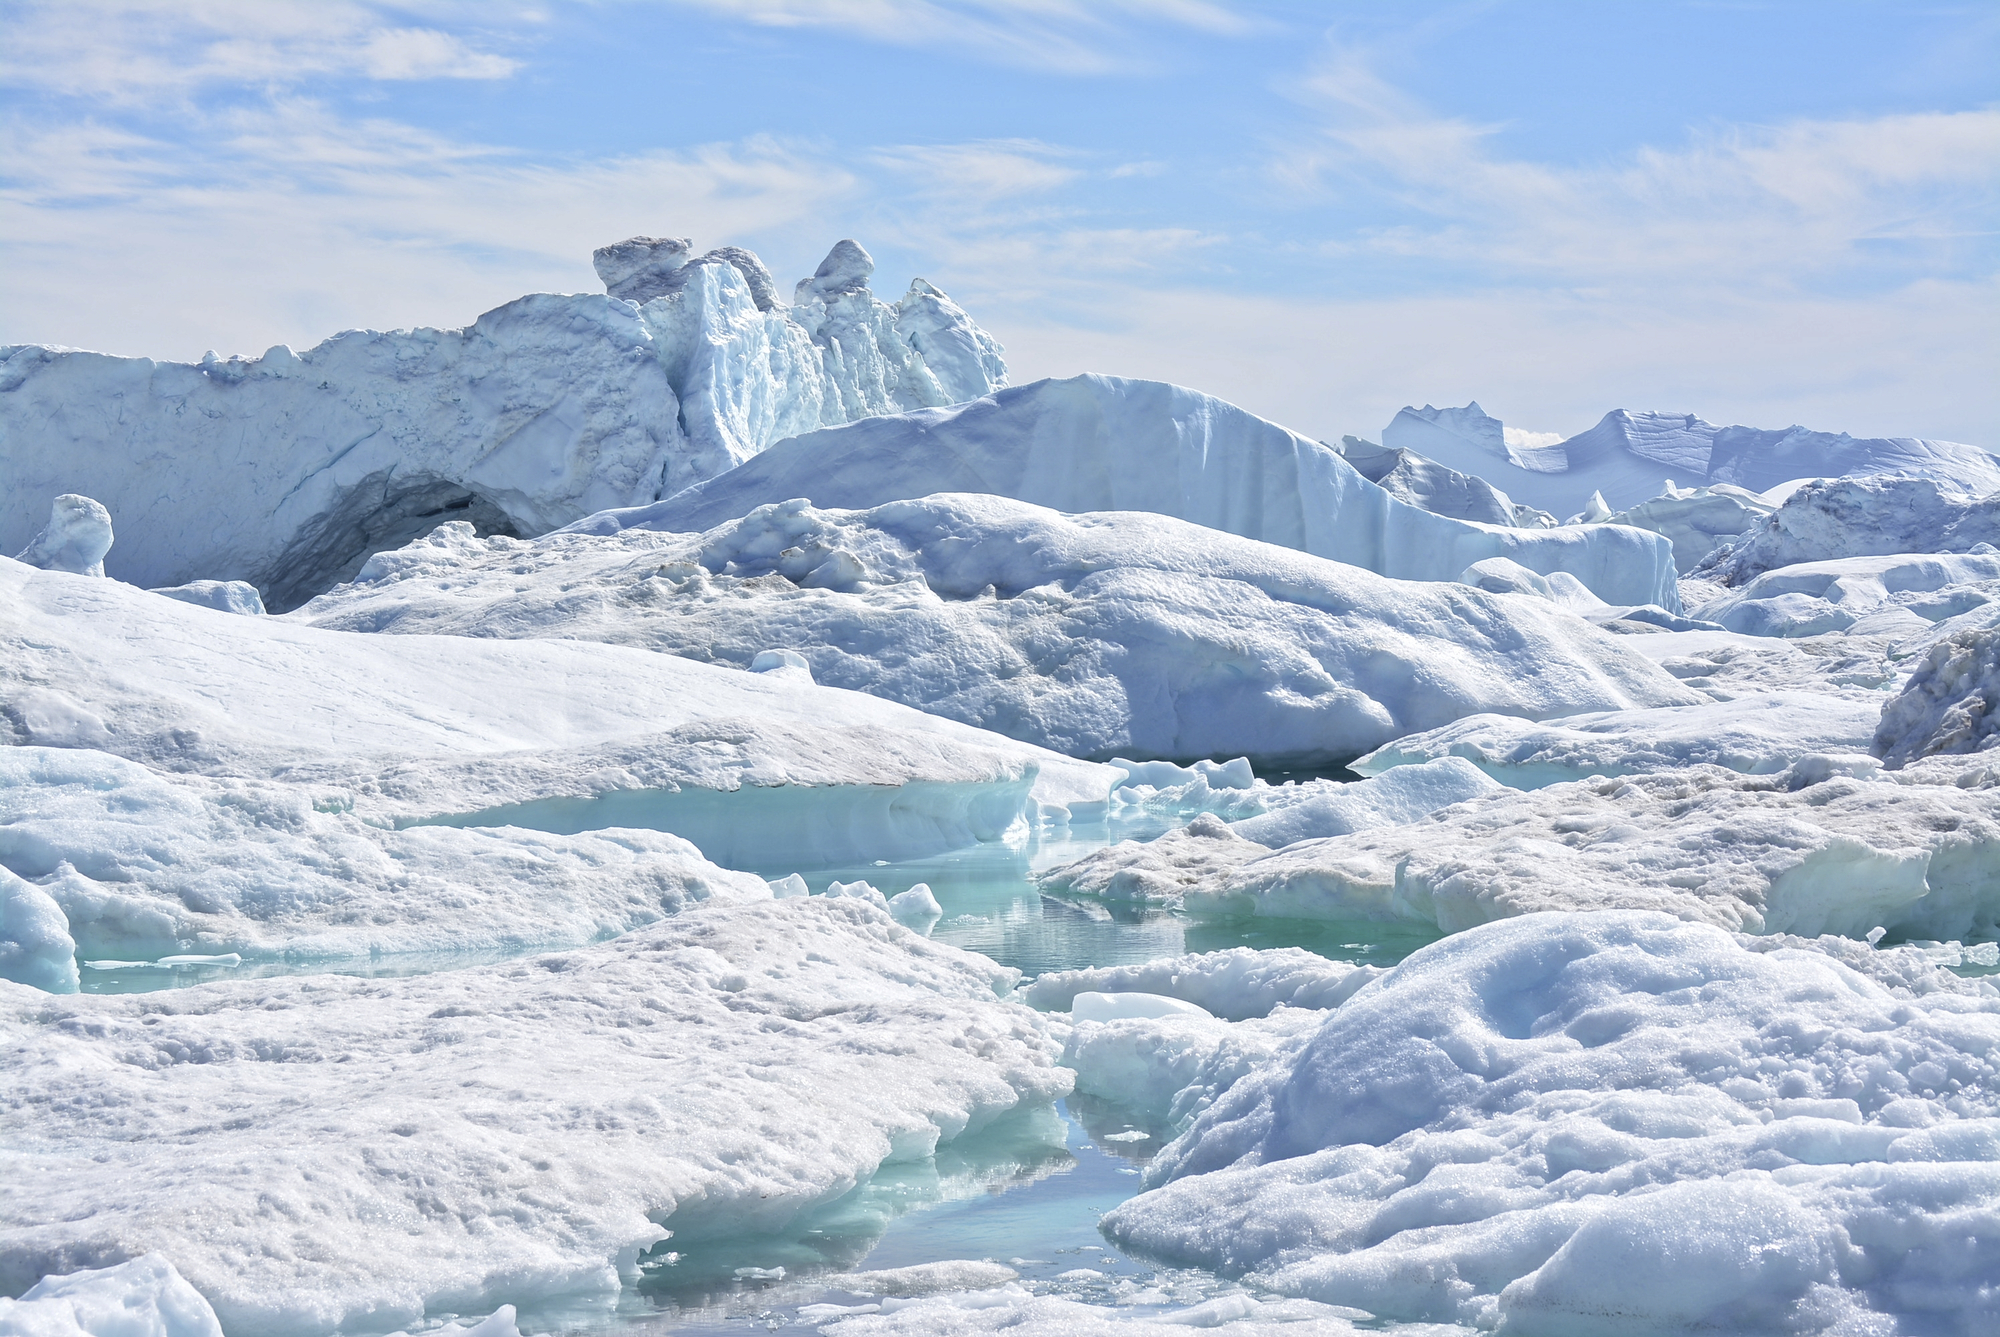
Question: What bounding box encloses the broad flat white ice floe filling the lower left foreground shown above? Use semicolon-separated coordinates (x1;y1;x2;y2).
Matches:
0;897;1070;1337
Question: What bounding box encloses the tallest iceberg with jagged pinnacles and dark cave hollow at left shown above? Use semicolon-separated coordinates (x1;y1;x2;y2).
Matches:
0;242;1006;610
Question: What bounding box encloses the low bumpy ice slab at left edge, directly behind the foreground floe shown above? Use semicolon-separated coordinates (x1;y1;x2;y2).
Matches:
0;747;770;972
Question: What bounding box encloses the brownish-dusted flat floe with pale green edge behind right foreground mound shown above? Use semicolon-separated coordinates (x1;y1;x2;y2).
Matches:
1168;757;2000;941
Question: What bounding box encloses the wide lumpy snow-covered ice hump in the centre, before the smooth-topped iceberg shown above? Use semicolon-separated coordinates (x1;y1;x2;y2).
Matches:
292;494;1696;768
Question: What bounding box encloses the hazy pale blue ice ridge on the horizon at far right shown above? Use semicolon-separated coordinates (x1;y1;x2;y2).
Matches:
1382;402;2000;516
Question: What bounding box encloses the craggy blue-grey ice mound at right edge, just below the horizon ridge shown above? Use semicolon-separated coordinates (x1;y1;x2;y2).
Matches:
1702;478;2000;586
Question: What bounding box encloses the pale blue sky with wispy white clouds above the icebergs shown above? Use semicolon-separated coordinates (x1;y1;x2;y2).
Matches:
0;0;2000;448
